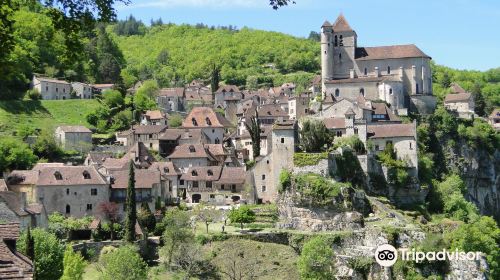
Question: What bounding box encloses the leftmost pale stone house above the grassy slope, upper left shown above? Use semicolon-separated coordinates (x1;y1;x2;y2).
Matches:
31;76;71;100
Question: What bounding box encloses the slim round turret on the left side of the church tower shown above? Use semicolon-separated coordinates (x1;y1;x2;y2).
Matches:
321;21;333;99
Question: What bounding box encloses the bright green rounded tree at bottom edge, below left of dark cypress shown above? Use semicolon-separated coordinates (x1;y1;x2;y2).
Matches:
98;245;147;280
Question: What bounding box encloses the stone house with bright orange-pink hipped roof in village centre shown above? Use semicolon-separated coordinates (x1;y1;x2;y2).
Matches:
182;107;232;144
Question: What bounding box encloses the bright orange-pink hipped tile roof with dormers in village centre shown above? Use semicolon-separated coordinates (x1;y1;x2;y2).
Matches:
182;107;232;128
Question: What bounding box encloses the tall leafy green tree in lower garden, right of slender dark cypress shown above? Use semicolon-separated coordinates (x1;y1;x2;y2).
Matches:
160;209;194;266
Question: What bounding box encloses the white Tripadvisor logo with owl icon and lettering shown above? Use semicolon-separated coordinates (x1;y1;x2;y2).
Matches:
375;244;481;267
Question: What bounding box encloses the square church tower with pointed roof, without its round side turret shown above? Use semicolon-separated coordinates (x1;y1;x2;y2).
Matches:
332;14;358;79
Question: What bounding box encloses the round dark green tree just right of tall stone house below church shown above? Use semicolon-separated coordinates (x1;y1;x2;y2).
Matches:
300;120;333;152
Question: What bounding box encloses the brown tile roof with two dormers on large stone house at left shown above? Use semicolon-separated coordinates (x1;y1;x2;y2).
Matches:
36;166;107;186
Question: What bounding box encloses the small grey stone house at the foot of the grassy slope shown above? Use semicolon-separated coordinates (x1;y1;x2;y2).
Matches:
55;125;92;153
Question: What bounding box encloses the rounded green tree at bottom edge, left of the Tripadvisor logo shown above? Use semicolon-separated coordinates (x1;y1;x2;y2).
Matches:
297;236;334;279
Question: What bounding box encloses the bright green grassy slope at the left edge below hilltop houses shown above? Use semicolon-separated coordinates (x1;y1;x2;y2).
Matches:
0;99;99;136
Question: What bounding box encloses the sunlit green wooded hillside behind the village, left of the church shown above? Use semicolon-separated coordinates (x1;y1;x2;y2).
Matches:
108;24;320;90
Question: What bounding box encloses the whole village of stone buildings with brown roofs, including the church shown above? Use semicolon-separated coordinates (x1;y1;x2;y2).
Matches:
0;15;500;236
